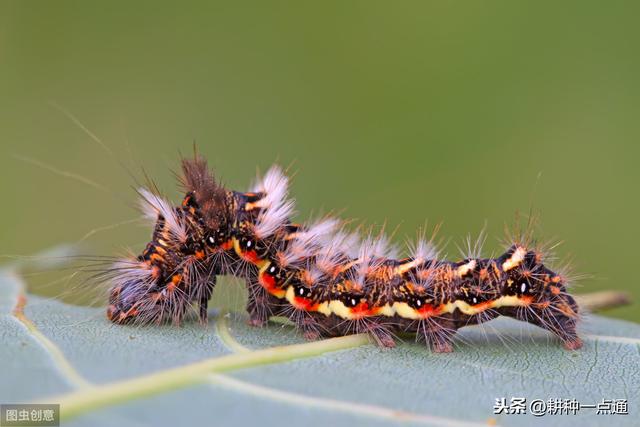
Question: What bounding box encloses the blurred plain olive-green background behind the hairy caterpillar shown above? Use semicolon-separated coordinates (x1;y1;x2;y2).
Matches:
0;0;640;321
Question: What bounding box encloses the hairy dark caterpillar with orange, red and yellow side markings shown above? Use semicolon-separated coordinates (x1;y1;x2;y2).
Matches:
105;155;582;352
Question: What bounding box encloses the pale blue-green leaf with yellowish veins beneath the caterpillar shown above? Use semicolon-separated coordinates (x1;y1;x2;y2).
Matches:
0;270;640;426
